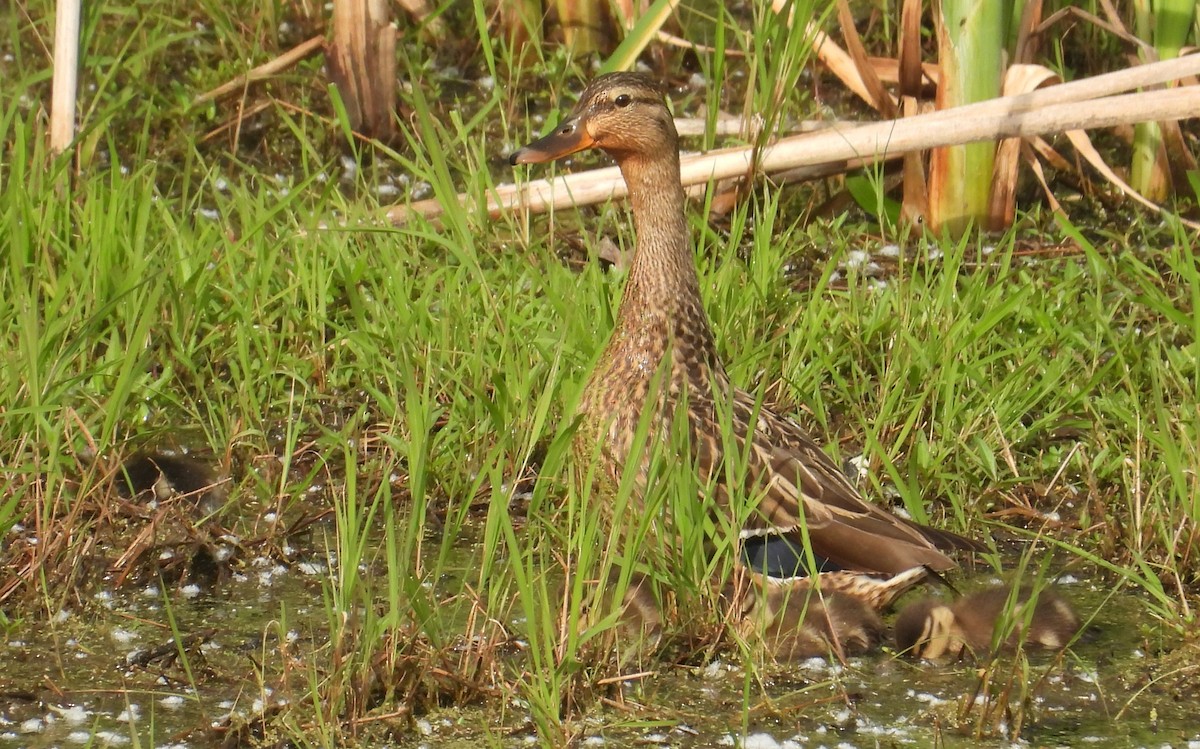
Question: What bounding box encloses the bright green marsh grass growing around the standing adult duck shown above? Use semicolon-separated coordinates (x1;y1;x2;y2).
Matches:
0;0;1200;744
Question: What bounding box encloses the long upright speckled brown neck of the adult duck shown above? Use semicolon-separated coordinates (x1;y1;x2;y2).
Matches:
617;146;716;364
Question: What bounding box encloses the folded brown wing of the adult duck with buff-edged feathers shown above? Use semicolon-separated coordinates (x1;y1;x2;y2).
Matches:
694;390;980;574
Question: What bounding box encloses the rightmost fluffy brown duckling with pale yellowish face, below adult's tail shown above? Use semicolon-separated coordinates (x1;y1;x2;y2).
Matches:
895;586;1080;659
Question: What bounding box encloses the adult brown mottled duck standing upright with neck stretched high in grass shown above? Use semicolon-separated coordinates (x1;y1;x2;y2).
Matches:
510;73;979;574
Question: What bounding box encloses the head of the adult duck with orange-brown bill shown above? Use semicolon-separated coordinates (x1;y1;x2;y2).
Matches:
509;73;678;166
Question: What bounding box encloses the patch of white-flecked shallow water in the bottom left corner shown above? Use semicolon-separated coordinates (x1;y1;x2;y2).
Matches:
0;547;324;747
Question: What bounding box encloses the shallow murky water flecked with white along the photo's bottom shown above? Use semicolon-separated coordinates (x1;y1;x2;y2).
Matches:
0;513;1200;748
